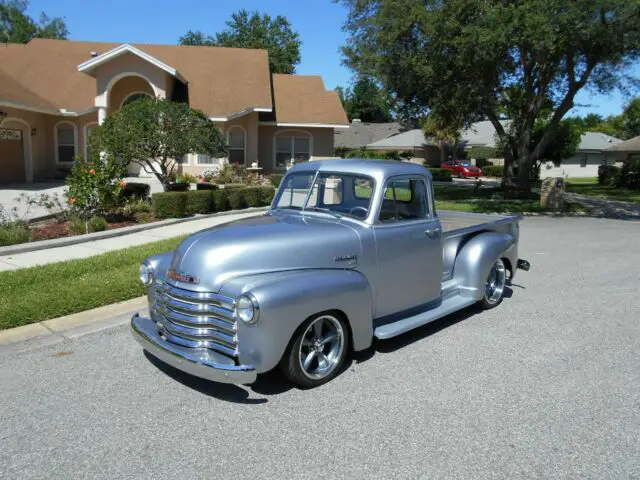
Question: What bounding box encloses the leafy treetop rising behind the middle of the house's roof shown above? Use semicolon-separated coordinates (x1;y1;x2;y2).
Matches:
179;9;302;73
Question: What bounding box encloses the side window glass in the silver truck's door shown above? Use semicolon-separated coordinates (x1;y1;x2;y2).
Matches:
379;179;429;223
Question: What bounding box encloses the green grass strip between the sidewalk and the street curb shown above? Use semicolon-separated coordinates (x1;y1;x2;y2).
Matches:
0;237;184;330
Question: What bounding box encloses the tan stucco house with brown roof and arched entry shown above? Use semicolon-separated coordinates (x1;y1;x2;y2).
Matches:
0;39;349;183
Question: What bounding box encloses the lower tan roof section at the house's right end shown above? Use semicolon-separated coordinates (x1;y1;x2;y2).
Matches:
273;74;349;125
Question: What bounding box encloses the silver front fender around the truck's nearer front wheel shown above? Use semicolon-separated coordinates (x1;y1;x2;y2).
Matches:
220;269;373;373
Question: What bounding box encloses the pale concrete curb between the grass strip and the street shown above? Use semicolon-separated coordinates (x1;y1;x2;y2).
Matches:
0;296;147;351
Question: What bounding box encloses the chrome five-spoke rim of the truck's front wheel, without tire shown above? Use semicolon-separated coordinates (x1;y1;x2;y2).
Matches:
298;315;345;380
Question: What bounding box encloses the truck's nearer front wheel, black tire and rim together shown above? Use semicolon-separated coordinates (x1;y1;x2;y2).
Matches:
280;313;349;388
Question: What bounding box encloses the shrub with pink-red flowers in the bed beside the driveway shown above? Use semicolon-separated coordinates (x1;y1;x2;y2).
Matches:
66;158;126;219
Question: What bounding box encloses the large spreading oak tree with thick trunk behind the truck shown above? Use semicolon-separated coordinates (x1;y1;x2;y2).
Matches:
342;0;640;189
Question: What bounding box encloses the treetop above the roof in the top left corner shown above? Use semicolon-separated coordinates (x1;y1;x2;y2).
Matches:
0;0;69;43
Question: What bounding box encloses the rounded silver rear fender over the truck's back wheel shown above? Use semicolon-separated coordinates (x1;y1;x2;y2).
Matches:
453;232;518;300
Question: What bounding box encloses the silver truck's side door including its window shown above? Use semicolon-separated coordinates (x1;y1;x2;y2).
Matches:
373;176;442;318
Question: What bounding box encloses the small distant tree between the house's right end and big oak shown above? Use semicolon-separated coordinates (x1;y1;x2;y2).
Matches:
336;77;393;123
